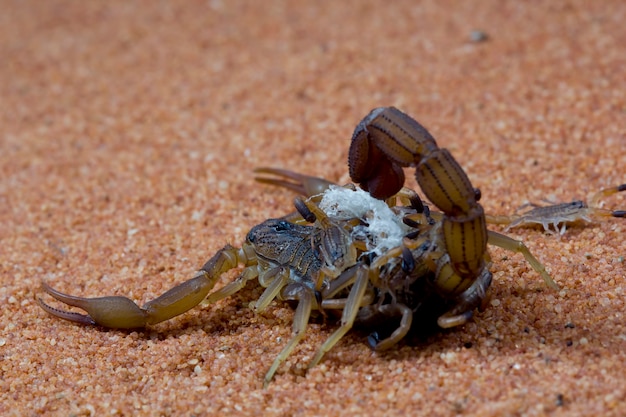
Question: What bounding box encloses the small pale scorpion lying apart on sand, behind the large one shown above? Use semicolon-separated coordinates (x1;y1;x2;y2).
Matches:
487;184;626;236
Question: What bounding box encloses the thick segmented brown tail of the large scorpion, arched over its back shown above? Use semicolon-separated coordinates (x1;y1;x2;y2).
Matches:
348;107;487;295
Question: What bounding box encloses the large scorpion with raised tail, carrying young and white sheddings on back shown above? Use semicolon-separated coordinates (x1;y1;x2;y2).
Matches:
38;107;621;385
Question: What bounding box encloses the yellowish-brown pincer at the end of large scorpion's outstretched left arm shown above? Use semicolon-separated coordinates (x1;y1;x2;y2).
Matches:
37;283;147;329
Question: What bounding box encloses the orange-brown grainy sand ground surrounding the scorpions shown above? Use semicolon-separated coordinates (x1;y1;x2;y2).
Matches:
0;0;626;416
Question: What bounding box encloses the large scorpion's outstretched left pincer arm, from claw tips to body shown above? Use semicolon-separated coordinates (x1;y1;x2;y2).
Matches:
37;245;247;329
